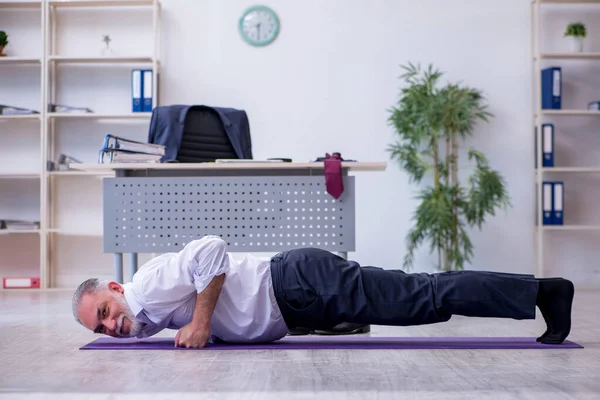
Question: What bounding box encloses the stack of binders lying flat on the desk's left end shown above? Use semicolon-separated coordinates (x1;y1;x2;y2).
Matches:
98;134;165;164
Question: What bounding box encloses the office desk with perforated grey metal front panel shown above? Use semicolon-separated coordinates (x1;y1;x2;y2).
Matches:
70;162;386;282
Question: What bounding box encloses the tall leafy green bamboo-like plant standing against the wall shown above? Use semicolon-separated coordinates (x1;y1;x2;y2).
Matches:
388;64;510;271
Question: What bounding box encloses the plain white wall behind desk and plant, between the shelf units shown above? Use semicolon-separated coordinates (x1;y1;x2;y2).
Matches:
161;0;533;272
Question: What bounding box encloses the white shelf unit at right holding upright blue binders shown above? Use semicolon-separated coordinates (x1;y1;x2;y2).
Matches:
530;0;600;276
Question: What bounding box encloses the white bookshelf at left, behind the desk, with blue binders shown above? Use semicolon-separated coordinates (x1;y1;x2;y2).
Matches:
0;0;161;291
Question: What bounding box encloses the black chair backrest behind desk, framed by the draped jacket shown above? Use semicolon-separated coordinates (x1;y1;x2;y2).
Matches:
177;106;239;163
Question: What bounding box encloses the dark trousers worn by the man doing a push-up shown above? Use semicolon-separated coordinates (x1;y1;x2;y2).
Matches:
271;248;538;329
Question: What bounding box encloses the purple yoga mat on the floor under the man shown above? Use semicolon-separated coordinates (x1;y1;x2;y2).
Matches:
80;335;583;350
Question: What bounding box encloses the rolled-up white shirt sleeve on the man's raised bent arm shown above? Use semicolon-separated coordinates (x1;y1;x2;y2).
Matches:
178;235;230;293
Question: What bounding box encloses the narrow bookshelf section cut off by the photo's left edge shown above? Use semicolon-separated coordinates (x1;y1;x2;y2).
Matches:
0;0;45;290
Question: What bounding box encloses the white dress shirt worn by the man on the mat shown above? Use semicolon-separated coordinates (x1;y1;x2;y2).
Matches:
123;235;288;342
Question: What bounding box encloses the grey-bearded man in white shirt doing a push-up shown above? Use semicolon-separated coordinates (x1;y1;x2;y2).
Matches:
73;236;574;347
